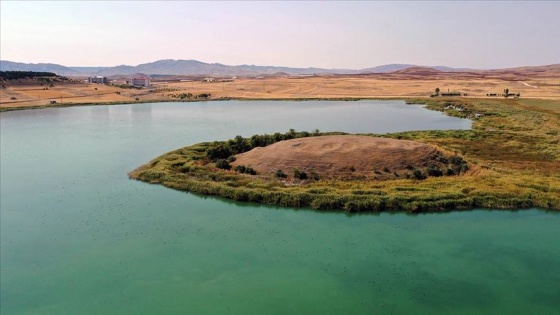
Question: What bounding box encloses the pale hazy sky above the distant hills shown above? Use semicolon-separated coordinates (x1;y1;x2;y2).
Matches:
0;0;560;69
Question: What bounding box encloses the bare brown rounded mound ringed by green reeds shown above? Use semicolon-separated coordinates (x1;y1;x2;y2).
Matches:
231;135;460;179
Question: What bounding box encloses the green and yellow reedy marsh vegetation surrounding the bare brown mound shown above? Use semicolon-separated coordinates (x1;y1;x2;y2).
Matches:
129;98;560;212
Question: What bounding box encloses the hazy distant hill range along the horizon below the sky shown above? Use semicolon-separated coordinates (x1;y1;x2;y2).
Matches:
0;59;560;77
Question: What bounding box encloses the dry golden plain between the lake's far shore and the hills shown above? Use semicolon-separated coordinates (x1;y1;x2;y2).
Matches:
0;68;560;110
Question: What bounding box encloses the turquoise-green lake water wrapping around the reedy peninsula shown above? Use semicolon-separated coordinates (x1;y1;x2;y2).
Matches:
0;101;560;315
